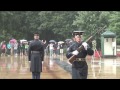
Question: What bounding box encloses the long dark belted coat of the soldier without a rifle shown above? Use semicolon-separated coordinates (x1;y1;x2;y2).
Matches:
28;40;44;72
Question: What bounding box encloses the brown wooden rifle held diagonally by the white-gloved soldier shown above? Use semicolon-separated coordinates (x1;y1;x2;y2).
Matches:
68;26;106;64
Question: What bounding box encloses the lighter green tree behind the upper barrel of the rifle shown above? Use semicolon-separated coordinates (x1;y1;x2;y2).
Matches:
73;11;110;48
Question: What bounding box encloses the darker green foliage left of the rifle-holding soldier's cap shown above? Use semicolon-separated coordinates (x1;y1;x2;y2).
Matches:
0;11;77;41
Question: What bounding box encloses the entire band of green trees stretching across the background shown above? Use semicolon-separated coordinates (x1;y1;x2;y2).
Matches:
0;11;120;48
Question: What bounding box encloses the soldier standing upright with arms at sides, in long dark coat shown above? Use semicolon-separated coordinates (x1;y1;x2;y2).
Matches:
28;33;44;79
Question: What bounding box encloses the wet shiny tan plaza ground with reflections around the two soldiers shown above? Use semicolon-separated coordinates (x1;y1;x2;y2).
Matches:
0;55;120;79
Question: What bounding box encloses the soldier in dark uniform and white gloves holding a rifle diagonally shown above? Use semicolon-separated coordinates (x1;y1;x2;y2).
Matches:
66;31;94;79
